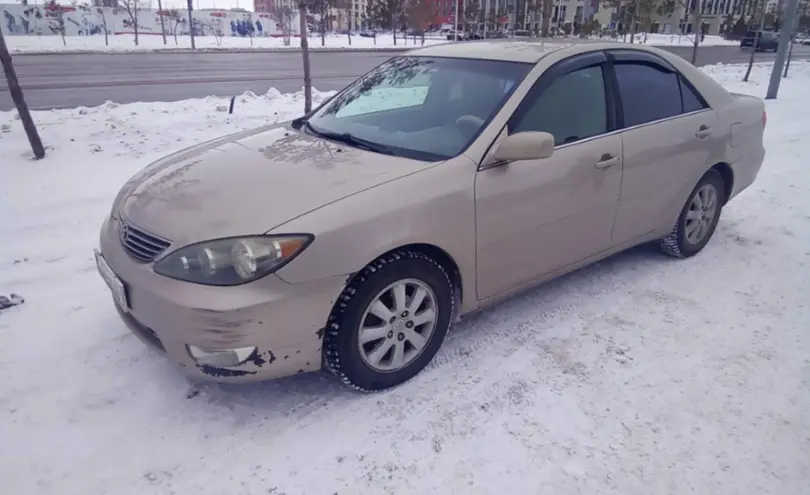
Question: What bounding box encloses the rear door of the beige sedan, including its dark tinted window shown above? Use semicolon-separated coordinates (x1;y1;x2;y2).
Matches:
608;50;726;244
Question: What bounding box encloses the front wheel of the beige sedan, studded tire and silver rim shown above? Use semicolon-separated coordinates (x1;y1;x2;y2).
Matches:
324;250;455;392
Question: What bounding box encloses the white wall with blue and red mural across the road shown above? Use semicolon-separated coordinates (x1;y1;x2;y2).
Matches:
0;4;298;37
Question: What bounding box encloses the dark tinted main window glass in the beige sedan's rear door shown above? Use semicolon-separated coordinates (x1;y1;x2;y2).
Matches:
615;63;680;127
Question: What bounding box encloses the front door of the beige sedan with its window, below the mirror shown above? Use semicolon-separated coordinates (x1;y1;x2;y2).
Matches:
475;63;622;299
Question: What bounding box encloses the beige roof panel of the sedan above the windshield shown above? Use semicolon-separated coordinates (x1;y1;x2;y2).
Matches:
408;39;676;64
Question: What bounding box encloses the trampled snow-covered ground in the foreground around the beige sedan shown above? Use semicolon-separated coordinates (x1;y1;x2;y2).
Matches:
0;63;810;495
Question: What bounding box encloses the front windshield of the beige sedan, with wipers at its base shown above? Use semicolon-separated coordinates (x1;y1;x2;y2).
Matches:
308;56;533;161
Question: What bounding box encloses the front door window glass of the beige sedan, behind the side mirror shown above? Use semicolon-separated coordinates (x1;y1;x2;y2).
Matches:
509;66;608;146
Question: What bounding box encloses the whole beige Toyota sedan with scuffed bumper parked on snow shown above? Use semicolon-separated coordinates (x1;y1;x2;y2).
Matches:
96;41;766;391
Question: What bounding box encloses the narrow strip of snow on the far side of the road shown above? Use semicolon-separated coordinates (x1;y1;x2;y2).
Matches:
6;34;739;53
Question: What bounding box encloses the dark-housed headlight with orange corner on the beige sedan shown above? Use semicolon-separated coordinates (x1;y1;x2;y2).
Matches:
155;234;313;285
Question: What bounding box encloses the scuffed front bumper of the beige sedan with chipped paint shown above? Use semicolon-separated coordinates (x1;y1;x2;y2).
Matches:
100;217;346;382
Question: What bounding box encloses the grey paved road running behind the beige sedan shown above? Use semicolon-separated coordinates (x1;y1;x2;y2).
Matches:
0;46;810;110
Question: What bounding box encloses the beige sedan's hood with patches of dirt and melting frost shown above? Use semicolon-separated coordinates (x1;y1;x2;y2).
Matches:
117;123;426;245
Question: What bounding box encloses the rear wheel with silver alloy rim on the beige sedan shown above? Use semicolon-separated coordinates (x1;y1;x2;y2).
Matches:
659;170;725;258
